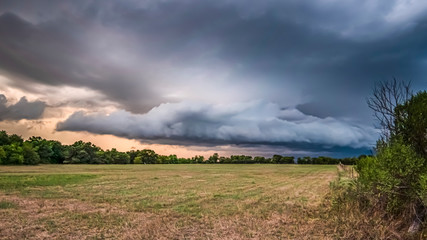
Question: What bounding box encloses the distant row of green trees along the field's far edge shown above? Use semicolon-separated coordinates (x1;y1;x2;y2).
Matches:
0;131;364;165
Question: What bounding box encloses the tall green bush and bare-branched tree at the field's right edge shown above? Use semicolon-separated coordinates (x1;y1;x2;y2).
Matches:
356;80;427;231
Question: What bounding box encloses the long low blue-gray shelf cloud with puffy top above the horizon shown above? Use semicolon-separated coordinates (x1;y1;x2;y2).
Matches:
57;101;377;149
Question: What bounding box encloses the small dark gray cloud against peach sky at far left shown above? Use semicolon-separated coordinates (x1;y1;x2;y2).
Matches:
0;94;46;121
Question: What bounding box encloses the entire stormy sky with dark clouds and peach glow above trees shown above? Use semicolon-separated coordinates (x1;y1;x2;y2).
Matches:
0;0;427;157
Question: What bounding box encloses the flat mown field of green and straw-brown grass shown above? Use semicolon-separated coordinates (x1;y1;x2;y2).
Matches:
0;164;337;239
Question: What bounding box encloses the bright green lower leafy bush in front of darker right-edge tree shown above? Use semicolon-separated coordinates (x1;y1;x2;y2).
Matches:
356;139;426;212
